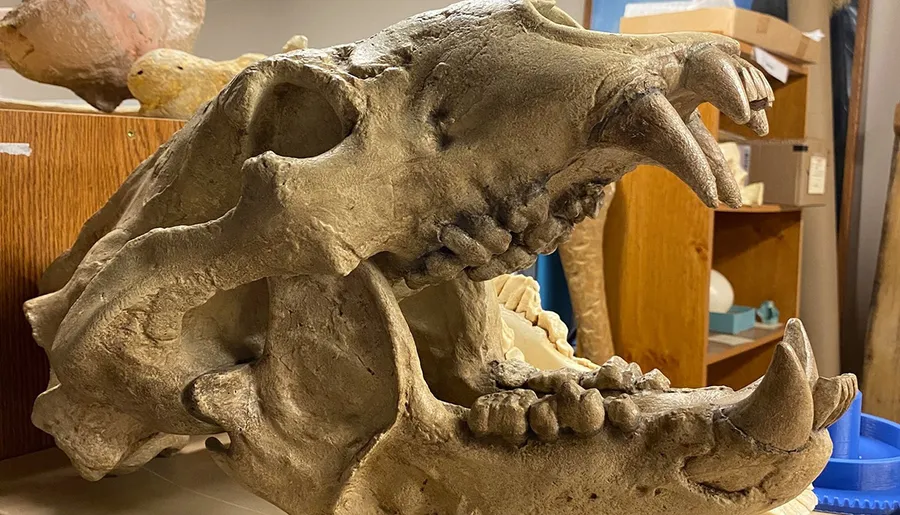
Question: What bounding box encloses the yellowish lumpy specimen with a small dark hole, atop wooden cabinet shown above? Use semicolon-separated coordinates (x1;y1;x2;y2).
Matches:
128;48;266;120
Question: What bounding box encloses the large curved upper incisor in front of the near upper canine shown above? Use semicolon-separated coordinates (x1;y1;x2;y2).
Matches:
685;49;750;124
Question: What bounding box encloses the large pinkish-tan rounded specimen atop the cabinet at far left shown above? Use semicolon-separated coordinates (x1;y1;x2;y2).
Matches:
0;0;206;112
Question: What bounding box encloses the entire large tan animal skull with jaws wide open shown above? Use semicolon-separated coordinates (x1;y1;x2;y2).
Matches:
25;0;856;515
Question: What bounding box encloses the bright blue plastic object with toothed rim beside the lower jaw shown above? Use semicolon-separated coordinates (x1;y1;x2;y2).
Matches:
813;393;900;515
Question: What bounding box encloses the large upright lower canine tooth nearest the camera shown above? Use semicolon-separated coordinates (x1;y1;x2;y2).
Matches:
725;343;815;451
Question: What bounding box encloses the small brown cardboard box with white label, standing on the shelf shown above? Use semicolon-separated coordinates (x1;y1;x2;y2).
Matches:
747;139;831;207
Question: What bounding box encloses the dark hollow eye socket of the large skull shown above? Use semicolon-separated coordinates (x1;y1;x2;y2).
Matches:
250;82;349;158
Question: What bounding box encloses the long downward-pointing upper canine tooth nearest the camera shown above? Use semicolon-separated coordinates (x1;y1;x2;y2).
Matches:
601;91;718;207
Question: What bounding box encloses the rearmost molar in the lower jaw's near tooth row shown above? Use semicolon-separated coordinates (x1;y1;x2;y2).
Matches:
468;390;537;444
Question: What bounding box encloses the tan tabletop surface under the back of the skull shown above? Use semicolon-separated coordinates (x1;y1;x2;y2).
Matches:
0;449;284;515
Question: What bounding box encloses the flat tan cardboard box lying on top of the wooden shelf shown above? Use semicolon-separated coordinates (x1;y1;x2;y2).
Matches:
619;7;822;63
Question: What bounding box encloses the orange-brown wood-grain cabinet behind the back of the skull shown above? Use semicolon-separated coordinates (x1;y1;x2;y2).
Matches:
0;110;182;459
